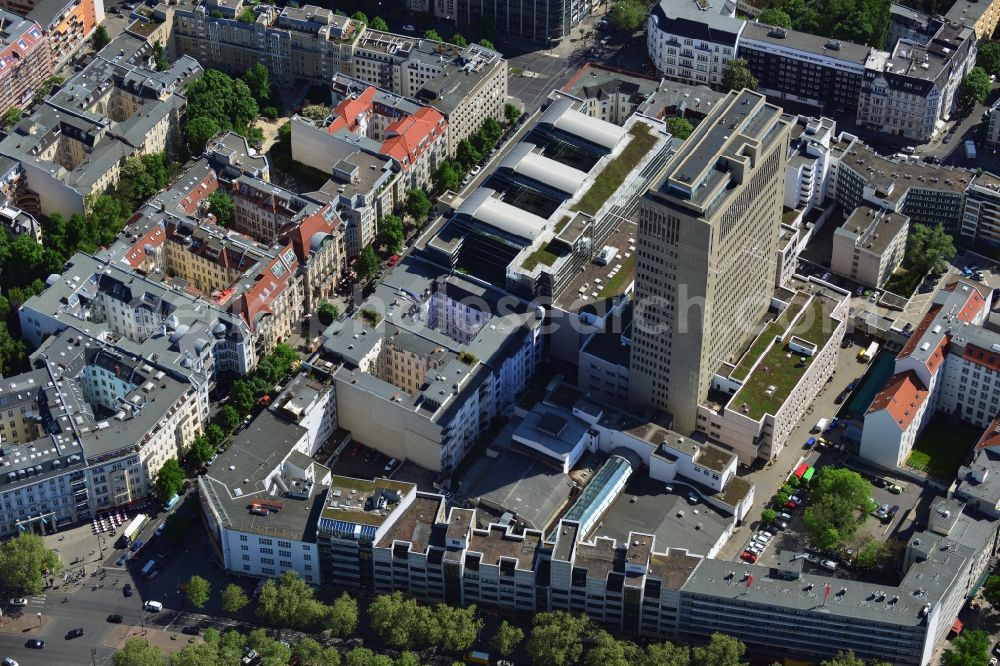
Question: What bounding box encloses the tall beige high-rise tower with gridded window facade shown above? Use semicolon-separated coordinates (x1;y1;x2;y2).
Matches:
629;90;791;433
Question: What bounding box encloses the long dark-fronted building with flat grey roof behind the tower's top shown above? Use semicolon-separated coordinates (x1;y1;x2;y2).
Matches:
739;21;871;116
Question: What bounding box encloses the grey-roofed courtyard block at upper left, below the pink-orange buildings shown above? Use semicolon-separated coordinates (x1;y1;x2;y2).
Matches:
0;35;202;217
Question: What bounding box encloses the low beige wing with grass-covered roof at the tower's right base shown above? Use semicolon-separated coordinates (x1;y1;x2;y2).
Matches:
696;280;850;465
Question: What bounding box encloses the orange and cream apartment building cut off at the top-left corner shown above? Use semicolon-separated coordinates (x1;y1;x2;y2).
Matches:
0;0;104;67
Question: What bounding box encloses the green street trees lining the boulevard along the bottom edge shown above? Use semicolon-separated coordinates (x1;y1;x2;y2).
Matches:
114;572;904;666
